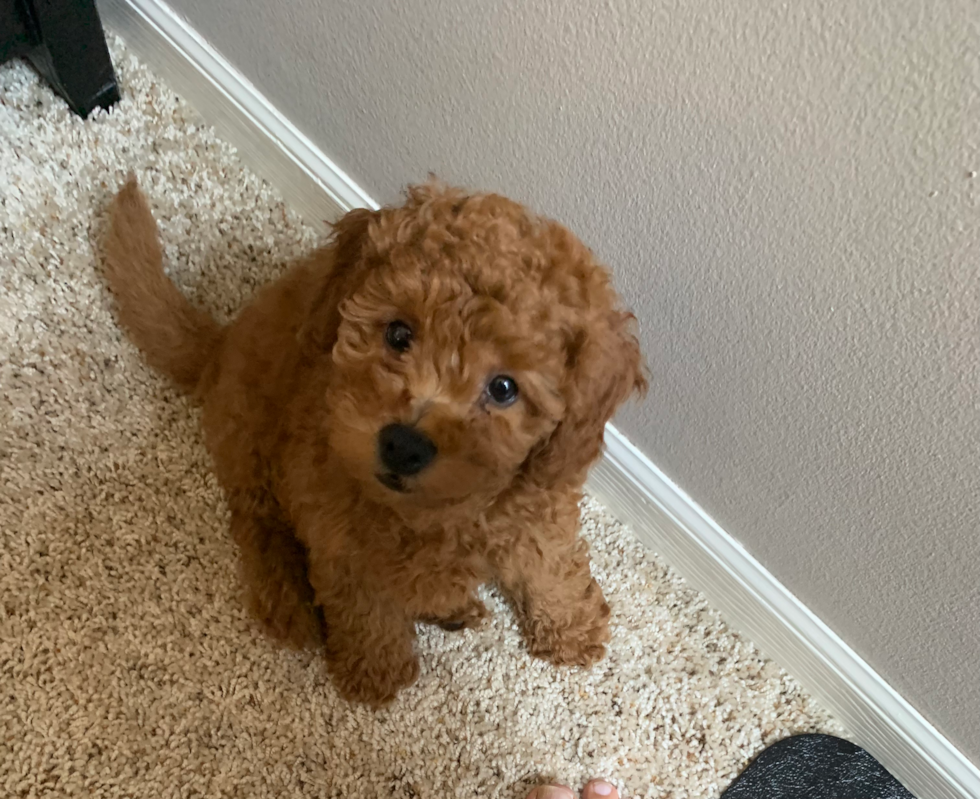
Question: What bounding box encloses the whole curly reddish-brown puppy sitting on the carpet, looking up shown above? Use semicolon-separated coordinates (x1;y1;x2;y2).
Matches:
104;178;646;705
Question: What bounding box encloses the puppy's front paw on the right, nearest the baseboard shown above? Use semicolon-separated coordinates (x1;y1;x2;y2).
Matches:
524;580;609;668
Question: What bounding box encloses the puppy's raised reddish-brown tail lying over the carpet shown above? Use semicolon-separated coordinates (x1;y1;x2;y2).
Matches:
104;175;222;391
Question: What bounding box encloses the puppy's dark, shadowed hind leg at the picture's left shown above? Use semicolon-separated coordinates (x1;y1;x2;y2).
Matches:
231;501;323;649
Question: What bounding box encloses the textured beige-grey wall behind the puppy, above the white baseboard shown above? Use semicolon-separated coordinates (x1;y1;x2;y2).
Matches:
165;0;980;762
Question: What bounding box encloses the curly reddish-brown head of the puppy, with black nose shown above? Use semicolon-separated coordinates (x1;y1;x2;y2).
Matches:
303;183;646;516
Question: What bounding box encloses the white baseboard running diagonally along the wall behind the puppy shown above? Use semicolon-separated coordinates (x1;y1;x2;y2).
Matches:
98;0;980;799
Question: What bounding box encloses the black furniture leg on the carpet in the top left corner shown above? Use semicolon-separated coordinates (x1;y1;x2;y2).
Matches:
19;0;119;117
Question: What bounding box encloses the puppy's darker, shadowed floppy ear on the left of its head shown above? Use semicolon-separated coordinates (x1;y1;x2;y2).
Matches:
300;208;378;352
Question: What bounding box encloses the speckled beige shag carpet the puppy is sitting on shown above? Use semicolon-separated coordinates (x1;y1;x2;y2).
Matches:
0;43;836;799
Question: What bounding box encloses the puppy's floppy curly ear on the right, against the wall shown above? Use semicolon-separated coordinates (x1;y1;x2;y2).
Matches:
526;302;647;488
